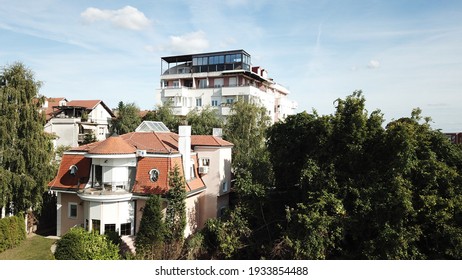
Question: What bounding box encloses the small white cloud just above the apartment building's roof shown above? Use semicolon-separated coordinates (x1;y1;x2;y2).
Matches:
166;30;209;53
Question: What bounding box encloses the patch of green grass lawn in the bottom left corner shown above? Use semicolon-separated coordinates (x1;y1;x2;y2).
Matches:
0;235;56;260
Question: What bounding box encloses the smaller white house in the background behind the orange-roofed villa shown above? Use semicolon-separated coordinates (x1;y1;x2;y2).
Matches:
42;97;114;147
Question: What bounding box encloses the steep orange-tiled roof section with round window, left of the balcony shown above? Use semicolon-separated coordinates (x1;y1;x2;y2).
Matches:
48;154;91;189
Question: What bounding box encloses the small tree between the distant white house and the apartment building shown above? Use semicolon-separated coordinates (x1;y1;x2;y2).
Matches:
111;101;141;135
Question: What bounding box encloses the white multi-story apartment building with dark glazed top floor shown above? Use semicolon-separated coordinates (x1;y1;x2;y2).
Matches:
157;50;297;122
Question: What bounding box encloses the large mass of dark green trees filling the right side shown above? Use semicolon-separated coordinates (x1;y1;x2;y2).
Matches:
267;91;462;259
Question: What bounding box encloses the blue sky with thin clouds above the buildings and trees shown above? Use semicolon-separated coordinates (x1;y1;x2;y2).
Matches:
0;0;462;132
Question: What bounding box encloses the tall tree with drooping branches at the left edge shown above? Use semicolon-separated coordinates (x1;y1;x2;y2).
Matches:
0;63;53;213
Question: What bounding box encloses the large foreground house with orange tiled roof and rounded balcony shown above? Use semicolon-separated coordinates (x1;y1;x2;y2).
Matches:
49;122;233;241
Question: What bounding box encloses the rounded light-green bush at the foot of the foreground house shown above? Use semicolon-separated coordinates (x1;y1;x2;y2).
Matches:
55;227;119;260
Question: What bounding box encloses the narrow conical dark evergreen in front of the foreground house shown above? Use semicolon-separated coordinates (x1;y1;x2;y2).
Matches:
135;195;166;260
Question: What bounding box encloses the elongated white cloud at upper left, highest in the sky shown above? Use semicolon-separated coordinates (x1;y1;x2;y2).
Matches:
80;6;151;30
